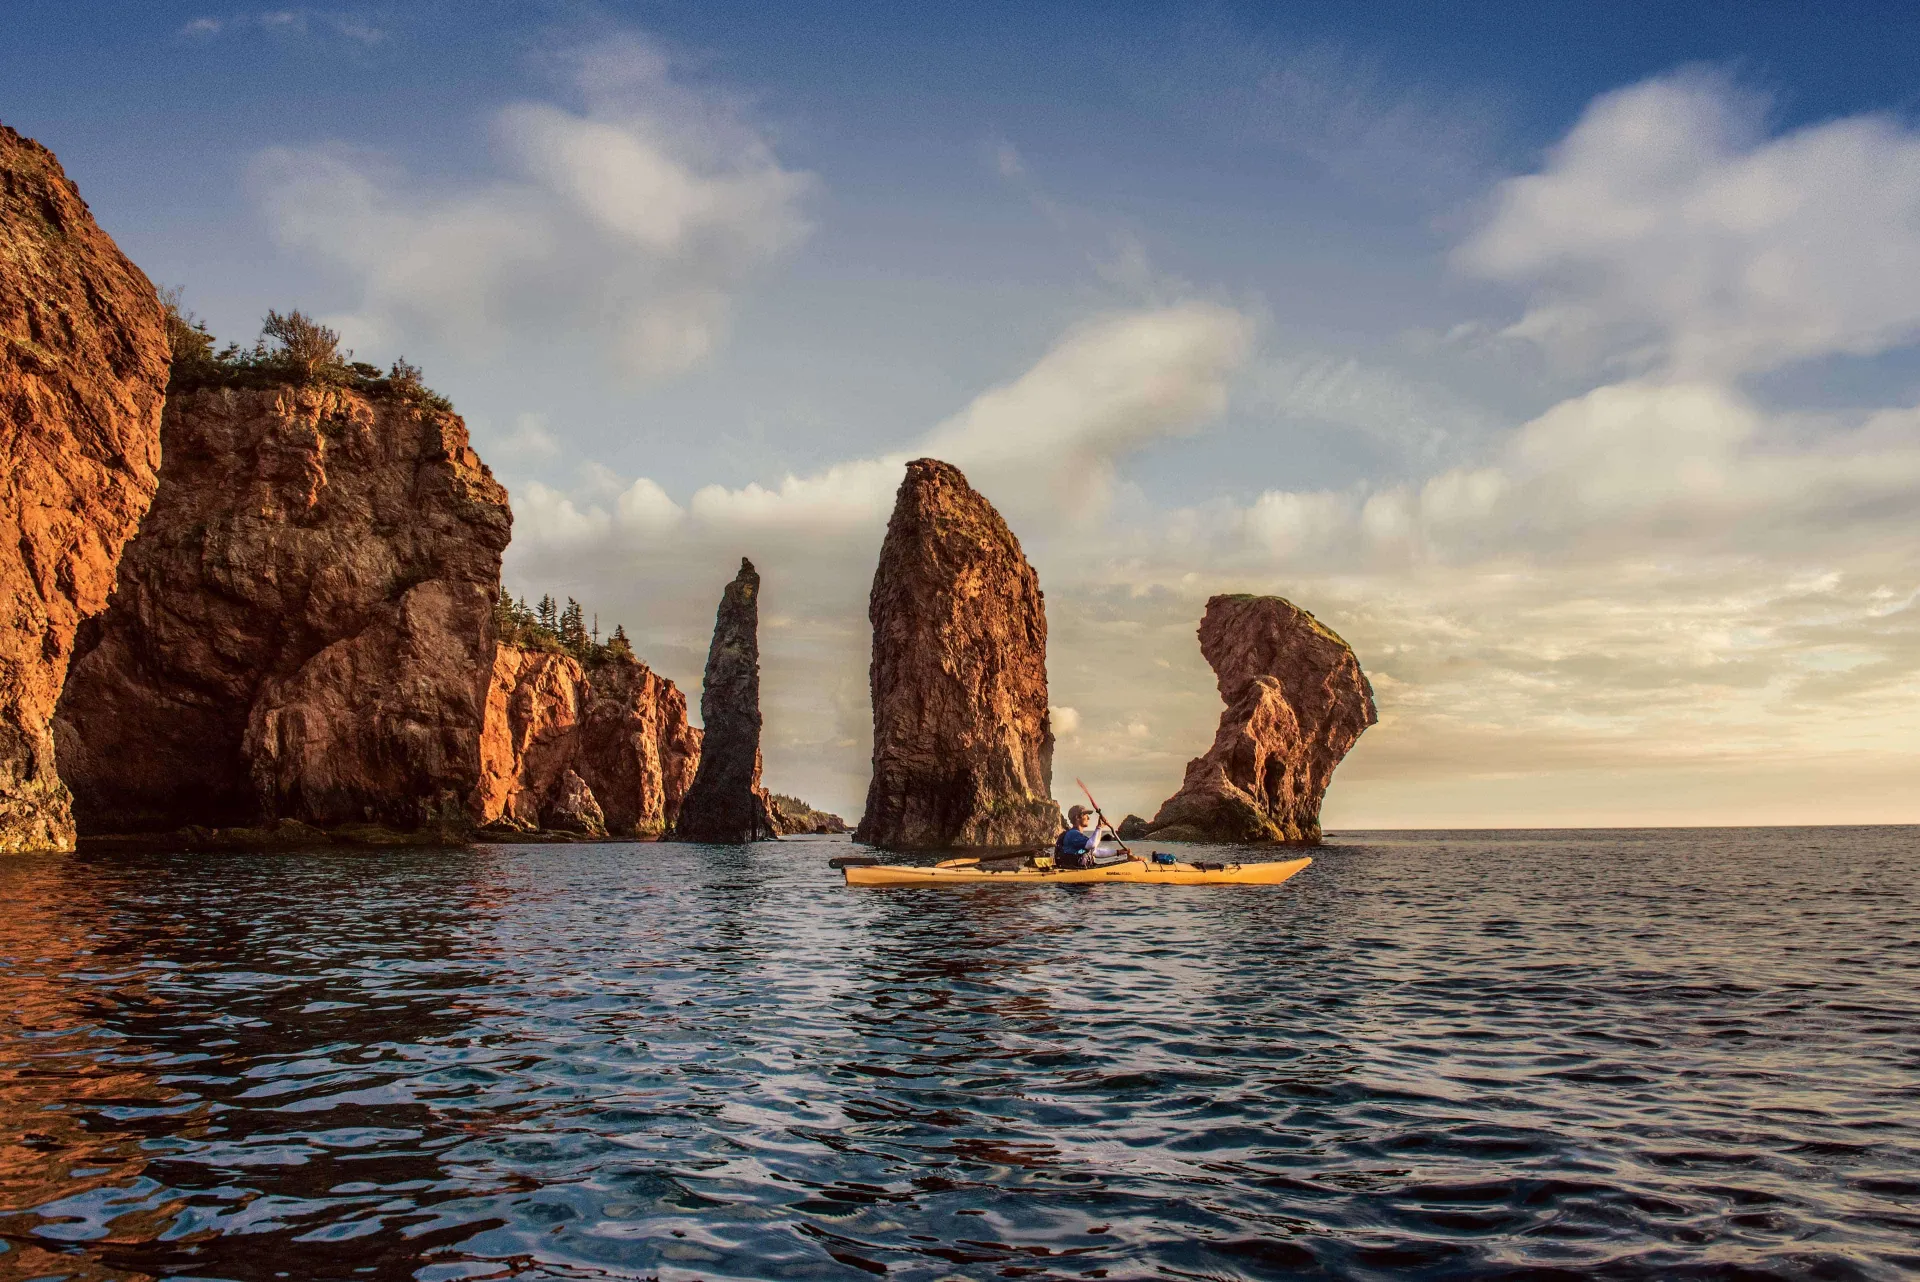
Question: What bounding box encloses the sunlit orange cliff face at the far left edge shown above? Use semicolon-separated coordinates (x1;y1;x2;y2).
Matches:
0;125;167;854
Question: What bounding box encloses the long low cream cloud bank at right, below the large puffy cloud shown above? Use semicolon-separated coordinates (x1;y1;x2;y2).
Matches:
1246;382;1920;566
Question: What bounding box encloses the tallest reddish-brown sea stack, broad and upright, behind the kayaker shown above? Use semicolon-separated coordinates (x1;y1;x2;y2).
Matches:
854;459;1060;850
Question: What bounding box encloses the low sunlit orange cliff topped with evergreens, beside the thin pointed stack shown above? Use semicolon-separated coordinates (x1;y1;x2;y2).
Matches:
476;645;701;837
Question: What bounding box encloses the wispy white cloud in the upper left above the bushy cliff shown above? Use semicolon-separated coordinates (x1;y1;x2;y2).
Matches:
253;36;814;376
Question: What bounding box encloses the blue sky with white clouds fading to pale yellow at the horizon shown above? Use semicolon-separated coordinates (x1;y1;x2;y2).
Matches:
11;0;1920;831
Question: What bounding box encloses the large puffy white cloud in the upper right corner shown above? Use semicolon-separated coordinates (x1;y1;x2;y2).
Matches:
1453;73;1920;378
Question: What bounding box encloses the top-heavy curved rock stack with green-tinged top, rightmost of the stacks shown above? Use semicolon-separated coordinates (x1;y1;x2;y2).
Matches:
1152;597;1379;844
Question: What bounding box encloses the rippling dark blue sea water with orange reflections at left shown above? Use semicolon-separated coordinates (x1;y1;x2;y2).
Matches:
0;829;1920;1280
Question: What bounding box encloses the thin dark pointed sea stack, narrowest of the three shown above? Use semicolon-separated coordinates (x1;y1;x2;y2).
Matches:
674;557;778;843
